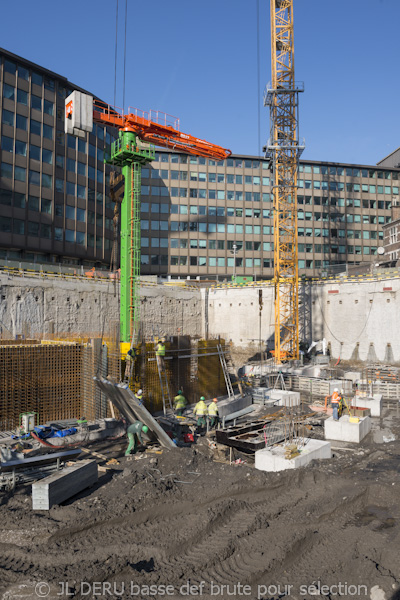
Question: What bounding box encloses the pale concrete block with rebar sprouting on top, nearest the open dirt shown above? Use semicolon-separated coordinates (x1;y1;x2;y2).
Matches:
255;439;332;471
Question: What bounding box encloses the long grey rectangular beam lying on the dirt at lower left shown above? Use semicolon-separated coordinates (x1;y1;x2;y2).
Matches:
32;460;98;510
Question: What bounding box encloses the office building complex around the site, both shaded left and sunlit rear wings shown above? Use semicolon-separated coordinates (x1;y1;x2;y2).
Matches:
0;50;399;279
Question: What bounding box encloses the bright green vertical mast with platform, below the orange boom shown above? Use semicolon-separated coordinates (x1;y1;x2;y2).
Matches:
106;131;155;344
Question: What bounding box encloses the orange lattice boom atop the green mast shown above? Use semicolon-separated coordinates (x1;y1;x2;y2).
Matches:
93;100;232;160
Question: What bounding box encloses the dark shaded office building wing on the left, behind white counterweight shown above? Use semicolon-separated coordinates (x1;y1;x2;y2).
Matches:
0;50;115;266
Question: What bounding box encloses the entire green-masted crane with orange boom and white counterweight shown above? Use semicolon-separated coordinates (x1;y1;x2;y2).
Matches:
65;91;231;347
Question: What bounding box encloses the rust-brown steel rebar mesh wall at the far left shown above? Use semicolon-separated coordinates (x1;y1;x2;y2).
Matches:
0;338;120;431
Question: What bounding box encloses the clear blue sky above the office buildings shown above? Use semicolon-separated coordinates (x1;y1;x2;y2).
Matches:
0;0;400;164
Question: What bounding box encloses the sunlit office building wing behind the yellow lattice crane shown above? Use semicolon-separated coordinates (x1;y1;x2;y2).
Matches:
142;151;399;279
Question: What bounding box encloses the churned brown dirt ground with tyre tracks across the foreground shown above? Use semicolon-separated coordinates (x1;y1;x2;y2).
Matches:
0;411;400;600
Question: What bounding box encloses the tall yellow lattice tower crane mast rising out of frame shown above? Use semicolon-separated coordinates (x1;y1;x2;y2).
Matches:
264;0;304;363
